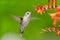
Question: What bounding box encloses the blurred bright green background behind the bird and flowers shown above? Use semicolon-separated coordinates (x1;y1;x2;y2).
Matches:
0;0;60;40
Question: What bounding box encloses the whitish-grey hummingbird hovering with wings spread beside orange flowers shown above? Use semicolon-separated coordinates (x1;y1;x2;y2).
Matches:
12;12;37;36
